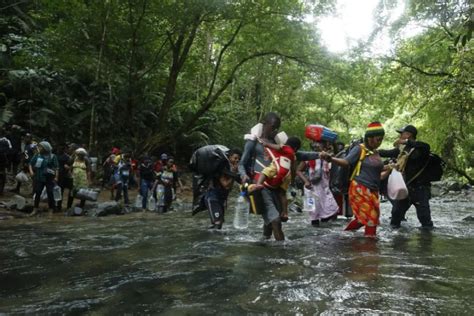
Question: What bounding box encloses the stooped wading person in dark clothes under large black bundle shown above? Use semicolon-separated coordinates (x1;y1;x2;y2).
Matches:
204;149;242;229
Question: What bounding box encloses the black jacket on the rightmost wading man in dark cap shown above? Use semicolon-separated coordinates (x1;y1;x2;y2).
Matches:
379;140;430;186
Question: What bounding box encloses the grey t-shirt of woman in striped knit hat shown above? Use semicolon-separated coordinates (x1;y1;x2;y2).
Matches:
344;146;383;191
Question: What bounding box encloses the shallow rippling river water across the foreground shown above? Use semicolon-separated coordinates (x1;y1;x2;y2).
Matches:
0;191;474;315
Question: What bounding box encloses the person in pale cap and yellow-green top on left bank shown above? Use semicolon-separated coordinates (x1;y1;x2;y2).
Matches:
67;148;92;209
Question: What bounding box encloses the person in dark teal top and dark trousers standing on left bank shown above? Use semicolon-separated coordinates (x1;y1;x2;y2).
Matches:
29;141;59;216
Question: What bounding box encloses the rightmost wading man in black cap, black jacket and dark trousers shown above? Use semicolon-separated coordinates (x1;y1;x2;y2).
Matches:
379;125;433;228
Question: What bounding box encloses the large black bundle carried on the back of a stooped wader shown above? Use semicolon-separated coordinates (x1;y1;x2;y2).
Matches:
189;145;230;177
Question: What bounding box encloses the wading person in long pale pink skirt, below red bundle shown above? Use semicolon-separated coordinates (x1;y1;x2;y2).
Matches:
296;141;339;227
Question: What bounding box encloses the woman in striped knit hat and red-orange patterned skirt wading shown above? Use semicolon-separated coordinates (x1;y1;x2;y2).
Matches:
320;122;389;237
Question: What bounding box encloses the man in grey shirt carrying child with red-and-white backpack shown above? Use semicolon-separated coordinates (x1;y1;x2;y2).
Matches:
239;112;318;241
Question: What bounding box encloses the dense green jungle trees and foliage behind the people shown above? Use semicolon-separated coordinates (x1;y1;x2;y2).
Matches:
0;0;474;183
